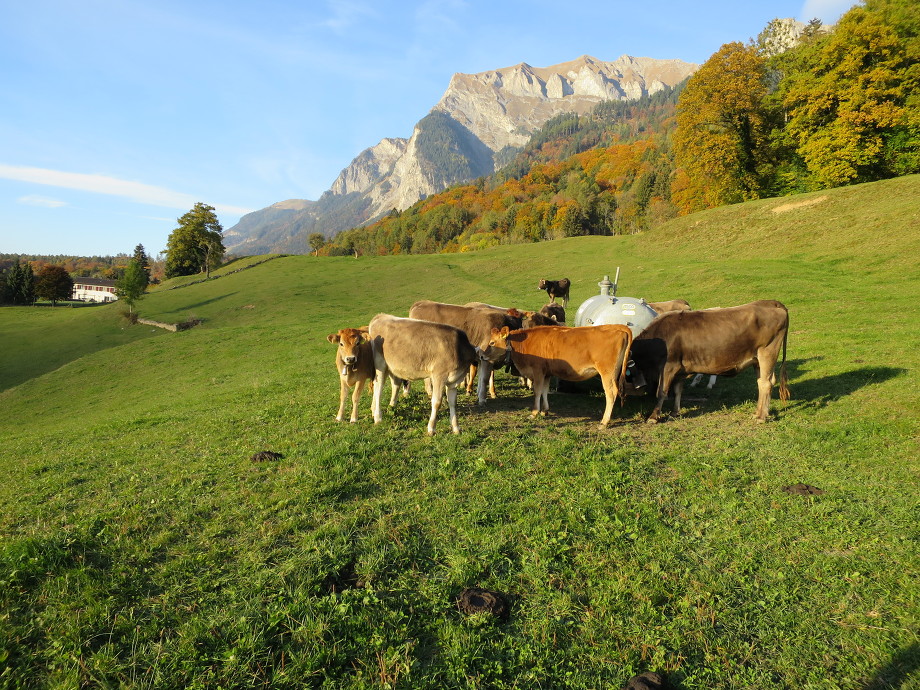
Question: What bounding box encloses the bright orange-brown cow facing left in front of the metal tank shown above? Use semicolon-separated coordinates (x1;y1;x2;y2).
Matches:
489;324;633;429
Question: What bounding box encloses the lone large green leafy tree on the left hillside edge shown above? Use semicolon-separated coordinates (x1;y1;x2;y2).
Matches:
166;202;226;278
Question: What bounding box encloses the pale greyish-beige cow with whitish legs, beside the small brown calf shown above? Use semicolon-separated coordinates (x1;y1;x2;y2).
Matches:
368;314;479;436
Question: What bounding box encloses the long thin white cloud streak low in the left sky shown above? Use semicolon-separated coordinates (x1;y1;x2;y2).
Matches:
0;163;252;215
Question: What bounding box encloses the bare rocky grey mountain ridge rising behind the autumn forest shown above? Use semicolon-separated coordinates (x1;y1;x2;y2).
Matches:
226;55;699;254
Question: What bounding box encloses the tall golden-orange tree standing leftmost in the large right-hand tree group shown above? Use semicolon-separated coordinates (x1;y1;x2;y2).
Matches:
674;42;769;210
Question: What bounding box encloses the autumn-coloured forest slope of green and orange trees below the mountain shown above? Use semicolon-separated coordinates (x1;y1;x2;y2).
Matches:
310;0;920;255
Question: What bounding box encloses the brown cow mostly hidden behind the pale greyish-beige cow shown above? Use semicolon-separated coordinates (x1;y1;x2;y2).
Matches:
409;300;521;405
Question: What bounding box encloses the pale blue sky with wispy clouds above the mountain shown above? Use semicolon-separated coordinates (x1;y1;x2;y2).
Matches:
0;0;854;256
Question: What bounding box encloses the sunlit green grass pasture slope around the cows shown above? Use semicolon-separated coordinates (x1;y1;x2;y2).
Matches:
0;177;920;690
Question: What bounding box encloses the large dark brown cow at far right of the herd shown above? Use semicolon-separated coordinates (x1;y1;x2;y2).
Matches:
632;300;789;423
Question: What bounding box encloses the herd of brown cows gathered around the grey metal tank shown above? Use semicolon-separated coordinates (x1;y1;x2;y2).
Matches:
327;279;789;435
